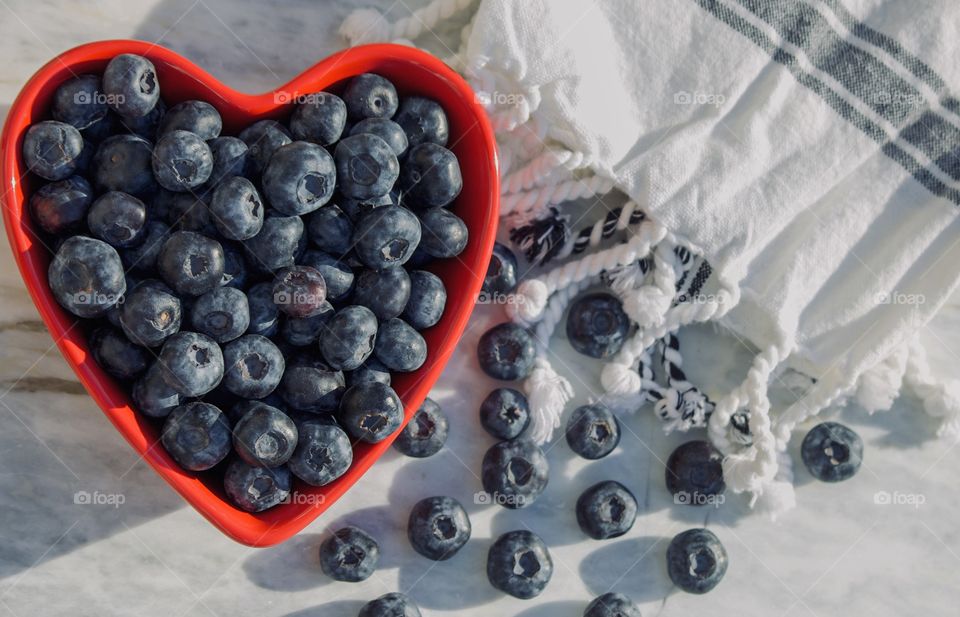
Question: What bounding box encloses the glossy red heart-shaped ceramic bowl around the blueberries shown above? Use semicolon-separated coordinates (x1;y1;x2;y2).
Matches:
0;41;500;546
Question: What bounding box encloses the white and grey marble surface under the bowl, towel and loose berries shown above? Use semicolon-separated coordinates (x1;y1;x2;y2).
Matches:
0;0;960;617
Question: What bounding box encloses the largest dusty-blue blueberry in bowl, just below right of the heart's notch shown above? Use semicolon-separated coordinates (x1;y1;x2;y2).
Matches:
263;141;337;215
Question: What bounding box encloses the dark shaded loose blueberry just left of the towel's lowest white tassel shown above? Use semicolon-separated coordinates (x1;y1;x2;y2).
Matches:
665;441;726;506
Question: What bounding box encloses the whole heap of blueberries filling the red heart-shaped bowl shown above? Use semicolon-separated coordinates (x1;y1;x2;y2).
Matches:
22;54;468;512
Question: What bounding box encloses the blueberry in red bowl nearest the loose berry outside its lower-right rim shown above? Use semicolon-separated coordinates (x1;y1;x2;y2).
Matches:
339;382;403;443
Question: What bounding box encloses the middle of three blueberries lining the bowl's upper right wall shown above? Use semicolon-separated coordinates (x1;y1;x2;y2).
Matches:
400;142;463;208
